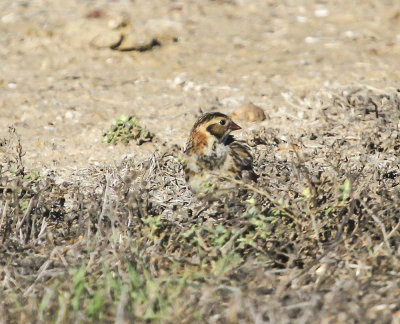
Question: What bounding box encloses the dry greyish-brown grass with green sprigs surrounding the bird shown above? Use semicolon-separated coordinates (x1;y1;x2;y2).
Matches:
0;86;400;323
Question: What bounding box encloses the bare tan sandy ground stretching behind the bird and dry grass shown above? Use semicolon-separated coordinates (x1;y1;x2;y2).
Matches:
0;0;400;172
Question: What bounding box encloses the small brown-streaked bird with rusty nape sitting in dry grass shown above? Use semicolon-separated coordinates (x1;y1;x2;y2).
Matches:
183;112;257;197
